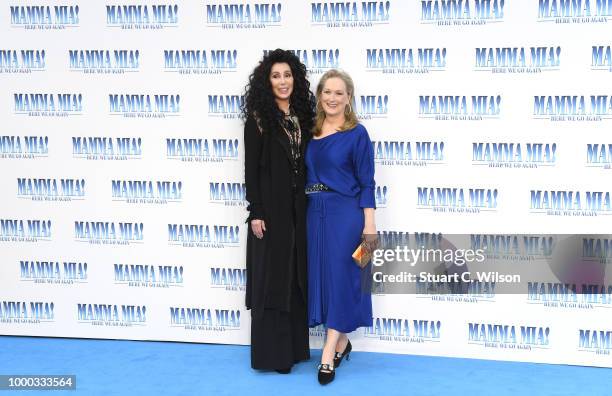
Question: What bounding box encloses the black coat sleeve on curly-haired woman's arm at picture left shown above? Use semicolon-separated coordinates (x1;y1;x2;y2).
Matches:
244;117;264;221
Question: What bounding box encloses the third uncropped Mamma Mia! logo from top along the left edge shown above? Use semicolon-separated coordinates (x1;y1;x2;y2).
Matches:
17;177;85;202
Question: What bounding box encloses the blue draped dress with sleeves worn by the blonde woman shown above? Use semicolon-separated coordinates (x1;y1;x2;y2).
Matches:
305;124;376;333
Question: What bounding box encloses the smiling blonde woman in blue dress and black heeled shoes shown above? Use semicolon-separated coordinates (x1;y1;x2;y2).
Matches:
305;70;376;384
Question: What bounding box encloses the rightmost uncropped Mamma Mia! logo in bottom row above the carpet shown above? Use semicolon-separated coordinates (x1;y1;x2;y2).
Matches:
467;322;550;351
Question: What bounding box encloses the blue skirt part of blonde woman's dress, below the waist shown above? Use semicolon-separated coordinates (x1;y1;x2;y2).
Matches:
306;191;372;333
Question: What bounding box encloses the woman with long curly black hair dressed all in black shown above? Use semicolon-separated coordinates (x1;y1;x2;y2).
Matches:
242;49;314;373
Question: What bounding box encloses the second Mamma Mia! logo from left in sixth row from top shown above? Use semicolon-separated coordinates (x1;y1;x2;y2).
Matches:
74;221;144;245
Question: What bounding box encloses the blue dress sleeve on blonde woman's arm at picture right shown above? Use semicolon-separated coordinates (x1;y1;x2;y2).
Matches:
353;128;376;208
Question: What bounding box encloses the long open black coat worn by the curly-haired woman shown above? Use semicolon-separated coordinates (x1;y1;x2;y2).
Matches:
244;116;310;312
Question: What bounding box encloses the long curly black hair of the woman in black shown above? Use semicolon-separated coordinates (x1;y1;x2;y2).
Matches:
241;48;315;134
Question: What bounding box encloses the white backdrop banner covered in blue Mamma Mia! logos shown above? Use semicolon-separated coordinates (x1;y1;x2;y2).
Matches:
0;0;612;367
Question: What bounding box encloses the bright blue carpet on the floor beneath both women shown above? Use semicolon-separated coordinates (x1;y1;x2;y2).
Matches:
0;336;612;396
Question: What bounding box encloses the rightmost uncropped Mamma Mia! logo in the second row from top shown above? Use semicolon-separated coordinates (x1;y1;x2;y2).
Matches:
474;46;561;74
